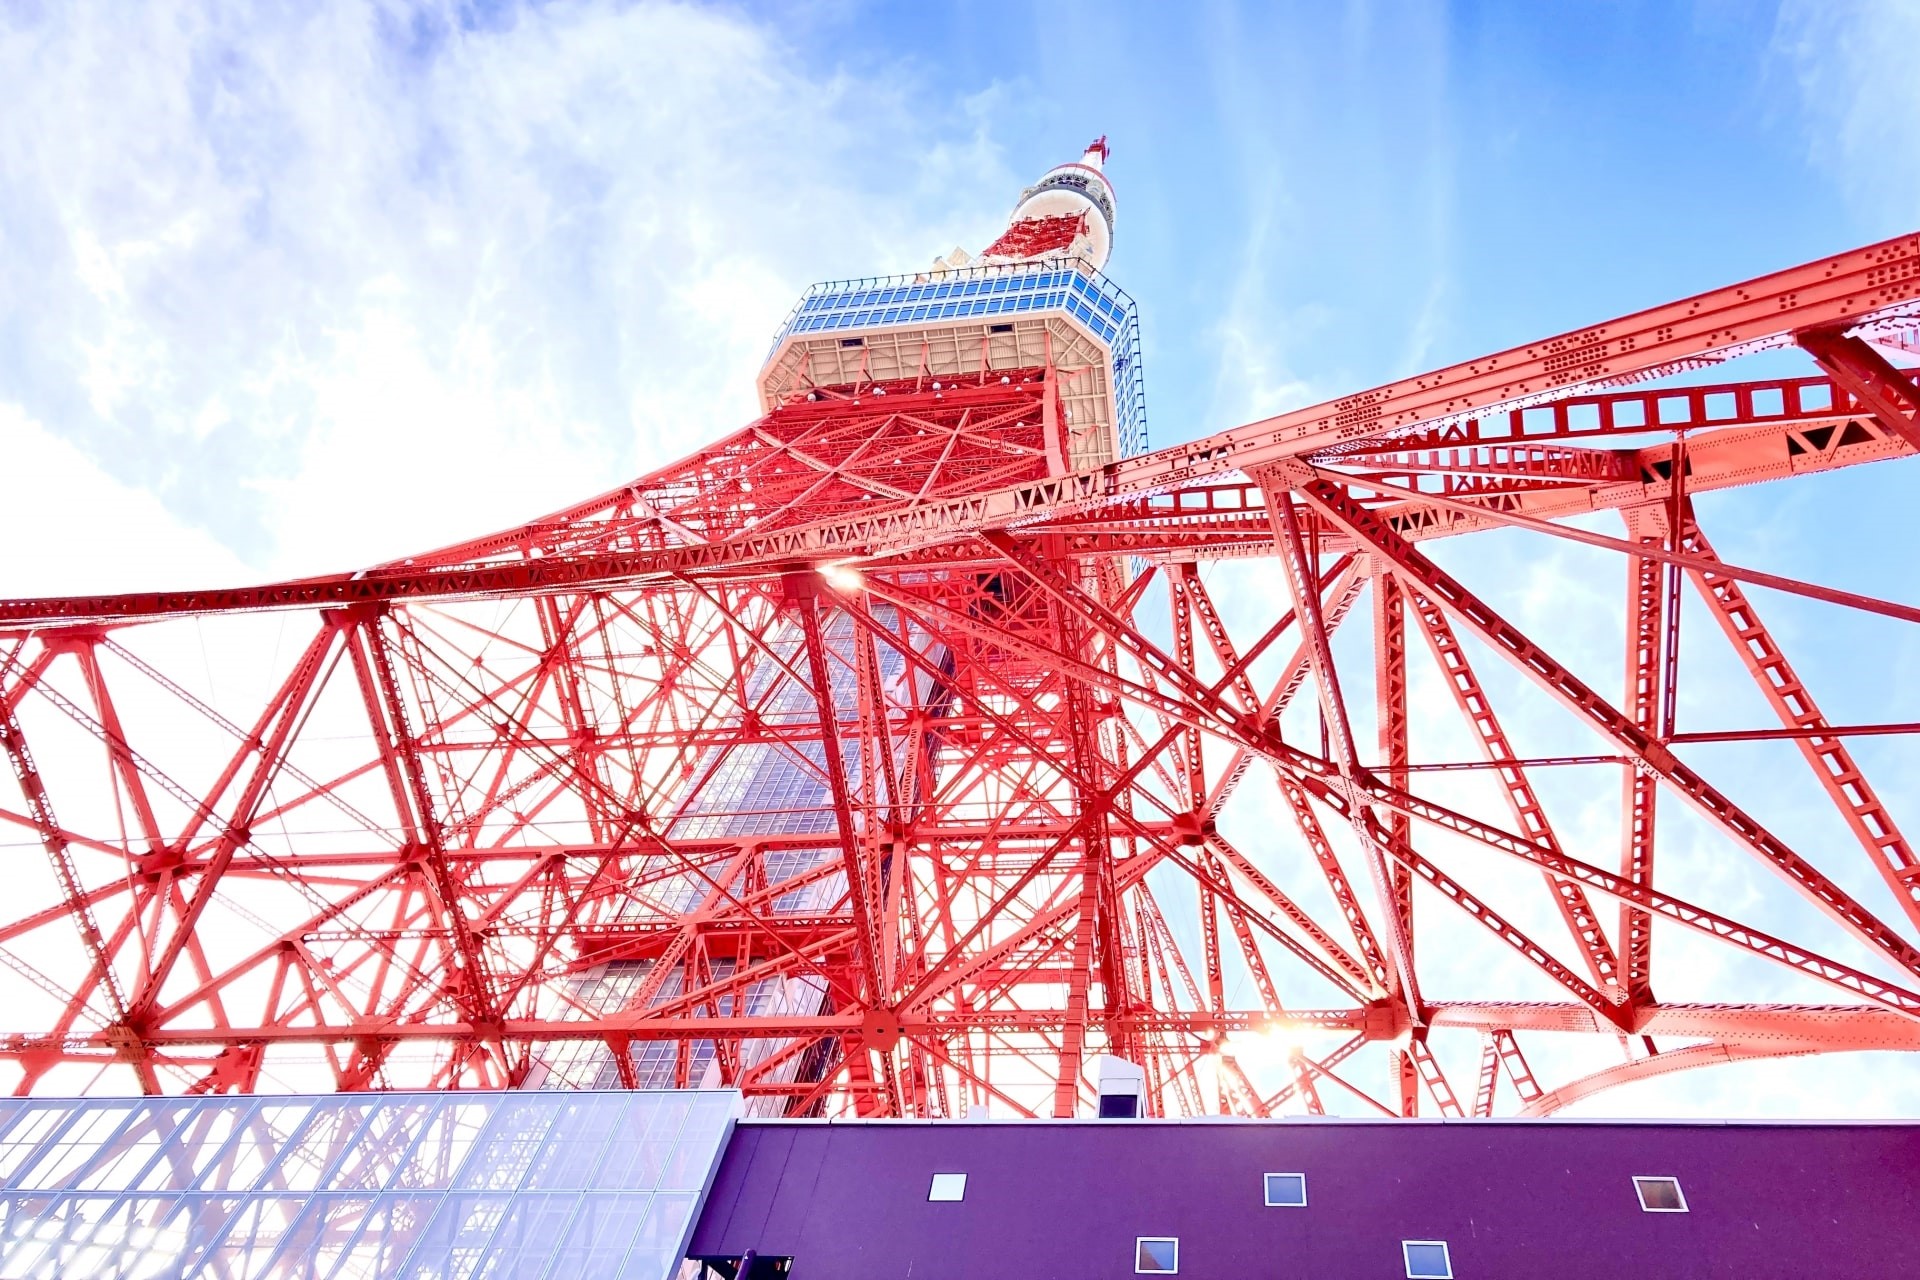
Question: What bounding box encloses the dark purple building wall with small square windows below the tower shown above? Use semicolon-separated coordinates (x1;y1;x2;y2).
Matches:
689;1121;1920;1280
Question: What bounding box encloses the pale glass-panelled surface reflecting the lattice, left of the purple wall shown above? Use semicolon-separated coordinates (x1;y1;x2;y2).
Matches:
0;1092;739;1280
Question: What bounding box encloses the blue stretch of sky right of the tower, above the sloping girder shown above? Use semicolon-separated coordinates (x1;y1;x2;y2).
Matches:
760;2;1916;441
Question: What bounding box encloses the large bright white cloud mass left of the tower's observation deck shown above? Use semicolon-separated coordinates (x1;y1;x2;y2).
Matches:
0;0;1018;591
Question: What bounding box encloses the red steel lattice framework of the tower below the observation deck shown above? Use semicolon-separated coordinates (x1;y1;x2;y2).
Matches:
0;227;1920;1115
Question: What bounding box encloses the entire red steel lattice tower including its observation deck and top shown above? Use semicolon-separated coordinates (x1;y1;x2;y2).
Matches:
0;140;1920;1117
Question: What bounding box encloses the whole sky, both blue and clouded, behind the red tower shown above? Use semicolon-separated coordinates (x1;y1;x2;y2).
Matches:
0;0;1920;1113
